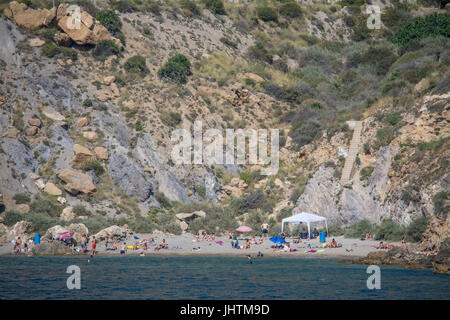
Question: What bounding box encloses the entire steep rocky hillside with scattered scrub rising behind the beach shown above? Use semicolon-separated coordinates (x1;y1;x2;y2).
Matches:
0;1;450;241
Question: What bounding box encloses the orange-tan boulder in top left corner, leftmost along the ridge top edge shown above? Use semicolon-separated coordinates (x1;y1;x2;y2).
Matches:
4;1;56;30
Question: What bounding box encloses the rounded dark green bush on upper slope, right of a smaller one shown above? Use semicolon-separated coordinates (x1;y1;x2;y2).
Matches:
158;54;191;84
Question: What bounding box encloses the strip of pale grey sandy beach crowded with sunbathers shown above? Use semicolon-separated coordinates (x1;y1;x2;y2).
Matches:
0;234;399;258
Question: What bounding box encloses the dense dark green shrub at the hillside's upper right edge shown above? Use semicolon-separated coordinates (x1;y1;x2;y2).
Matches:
389;14;450;47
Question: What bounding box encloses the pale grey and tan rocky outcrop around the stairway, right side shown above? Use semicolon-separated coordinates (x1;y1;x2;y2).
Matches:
294;94;450;238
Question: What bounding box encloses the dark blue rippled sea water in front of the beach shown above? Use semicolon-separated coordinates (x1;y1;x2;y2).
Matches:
0;256;450;299
